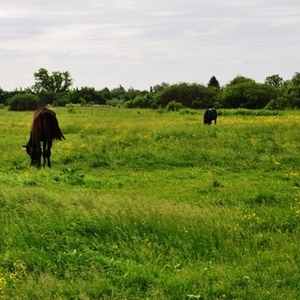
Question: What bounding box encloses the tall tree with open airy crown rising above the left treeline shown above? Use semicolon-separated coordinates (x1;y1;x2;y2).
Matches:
32;68;73;93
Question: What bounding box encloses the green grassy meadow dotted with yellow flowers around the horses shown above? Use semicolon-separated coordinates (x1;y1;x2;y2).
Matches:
0;106;300;300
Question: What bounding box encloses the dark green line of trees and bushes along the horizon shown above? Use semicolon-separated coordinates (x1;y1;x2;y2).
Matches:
0;68;300;111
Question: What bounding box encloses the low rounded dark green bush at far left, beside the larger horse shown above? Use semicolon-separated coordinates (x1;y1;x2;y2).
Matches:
8;93;40;111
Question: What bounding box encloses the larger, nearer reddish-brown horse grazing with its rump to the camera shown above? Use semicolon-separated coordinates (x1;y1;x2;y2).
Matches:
23;107;65;168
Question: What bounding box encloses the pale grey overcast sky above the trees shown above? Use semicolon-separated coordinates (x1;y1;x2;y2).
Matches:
0;0;300;91
